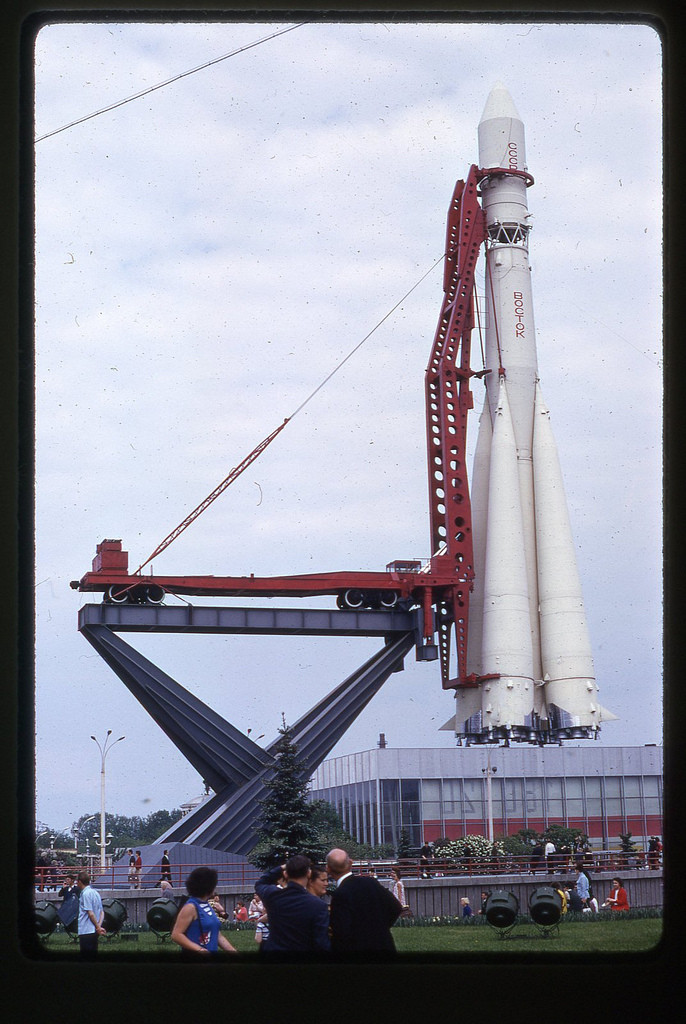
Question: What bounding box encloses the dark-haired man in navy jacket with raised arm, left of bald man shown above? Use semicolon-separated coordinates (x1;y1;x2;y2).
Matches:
255;854;331;953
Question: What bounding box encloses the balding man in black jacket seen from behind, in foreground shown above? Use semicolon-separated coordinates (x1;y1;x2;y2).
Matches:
327;850;402;954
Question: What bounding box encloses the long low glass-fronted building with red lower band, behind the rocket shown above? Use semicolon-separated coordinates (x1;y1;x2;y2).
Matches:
310;743;662;849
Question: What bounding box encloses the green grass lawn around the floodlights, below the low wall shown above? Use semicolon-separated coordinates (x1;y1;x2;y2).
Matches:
34;918;662;959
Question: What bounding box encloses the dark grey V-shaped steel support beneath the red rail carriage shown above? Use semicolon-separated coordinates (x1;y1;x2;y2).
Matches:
79;603;423;856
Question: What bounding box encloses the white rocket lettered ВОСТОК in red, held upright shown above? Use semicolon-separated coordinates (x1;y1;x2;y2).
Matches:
444;84;616;742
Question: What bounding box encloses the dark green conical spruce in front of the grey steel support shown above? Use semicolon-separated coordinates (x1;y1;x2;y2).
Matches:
250;716;326;870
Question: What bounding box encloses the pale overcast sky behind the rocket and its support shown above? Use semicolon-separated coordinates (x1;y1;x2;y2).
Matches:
29;23;662;828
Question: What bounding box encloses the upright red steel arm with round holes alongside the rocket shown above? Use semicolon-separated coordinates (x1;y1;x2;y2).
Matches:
425;165;486;688
